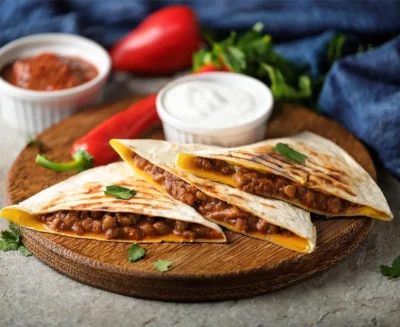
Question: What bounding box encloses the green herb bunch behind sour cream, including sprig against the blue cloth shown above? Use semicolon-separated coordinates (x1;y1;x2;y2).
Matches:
193;23;356;107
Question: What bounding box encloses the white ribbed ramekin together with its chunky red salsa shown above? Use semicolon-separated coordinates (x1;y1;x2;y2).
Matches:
0;33;111;134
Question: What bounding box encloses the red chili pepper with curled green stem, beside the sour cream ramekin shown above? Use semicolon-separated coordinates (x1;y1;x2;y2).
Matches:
36;94;160;171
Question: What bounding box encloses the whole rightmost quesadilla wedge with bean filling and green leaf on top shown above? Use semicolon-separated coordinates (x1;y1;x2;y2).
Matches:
176;132;393;220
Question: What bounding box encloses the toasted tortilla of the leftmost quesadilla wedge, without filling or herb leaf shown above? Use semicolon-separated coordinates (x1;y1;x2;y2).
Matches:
0;162;226;243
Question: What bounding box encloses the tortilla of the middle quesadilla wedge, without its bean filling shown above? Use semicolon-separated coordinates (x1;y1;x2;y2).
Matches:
110;140;316;253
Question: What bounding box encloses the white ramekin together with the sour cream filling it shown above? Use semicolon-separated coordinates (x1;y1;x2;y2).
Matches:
157;72;274;147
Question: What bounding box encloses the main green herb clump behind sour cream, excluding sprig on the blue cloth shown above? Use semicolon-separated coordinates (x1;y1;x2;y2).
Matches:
193;23;312;100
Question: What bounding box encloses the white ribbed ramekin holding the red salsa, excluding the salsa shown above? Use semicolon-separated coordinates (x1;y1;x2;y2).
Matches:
0;33;111;134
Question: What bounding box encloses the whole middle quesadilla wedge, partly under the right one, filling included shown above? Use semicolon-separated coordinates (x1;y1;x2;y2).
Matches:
110;140;316;253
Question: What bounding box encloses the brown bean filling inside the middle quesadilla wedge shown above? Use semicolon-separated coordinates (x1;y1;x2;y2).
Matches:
133;154;293;236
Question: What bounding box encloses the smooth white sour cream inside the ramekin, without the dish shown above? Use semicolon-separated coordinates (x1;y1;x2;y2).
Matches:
163;80;260;128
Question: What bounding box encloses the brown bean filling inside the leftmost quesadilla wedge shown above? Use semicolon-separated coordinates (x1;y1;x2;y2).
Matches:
37;210;222;241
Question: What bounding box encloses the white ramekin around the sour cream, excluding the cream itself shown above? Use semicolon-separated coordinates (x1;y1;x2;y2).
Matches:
157;72;274;147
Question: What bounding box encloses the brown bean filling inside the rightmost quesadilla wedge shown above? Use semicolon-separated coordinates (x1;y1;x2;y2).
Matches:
194;157;357;214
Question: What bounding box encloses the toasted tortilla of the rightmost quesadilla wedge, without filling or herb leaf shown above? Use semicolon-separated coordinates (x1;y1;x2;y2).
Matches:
177;132;393;220
